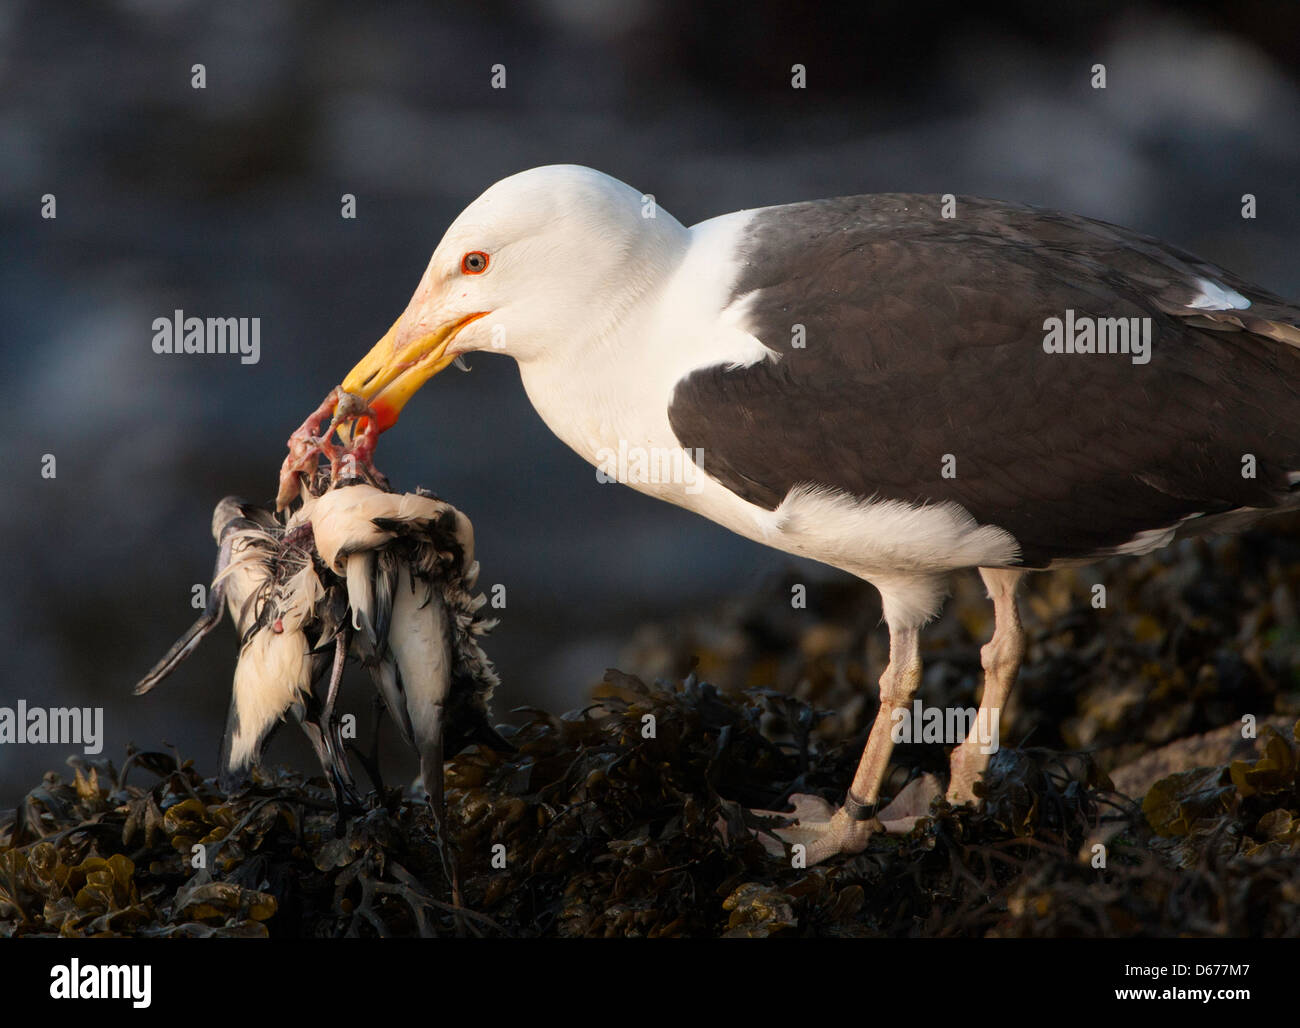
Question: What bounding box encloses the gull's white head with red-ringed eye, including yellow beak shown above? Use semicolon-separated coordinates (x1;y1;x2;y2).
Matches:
342;164;688;431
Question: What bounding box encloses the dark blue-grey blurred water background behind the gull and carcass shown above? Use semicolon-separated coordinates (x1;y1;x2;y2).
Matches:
0;0;1300;804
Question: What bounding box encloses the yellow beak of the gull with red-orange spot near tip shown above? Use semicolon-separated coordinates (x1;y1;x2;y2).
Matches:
341;311;488;431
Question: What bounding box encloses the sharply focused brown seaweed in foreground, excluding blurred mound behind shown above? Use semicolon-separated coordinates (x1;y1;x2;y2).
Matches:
0;672;1300;937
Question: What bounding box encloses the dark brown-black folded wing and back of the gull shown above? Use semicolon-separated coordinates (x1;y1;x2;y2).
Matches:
670;195;1300;567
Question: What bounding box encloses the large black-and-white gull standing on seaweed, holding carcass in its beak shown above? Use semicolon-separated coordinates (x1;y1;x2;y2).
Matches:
319;166;1300;863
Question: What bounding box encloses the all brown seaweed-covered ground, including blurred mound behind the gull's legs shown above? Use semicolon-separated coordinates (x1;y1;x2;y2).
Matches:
0;519;1300;937
